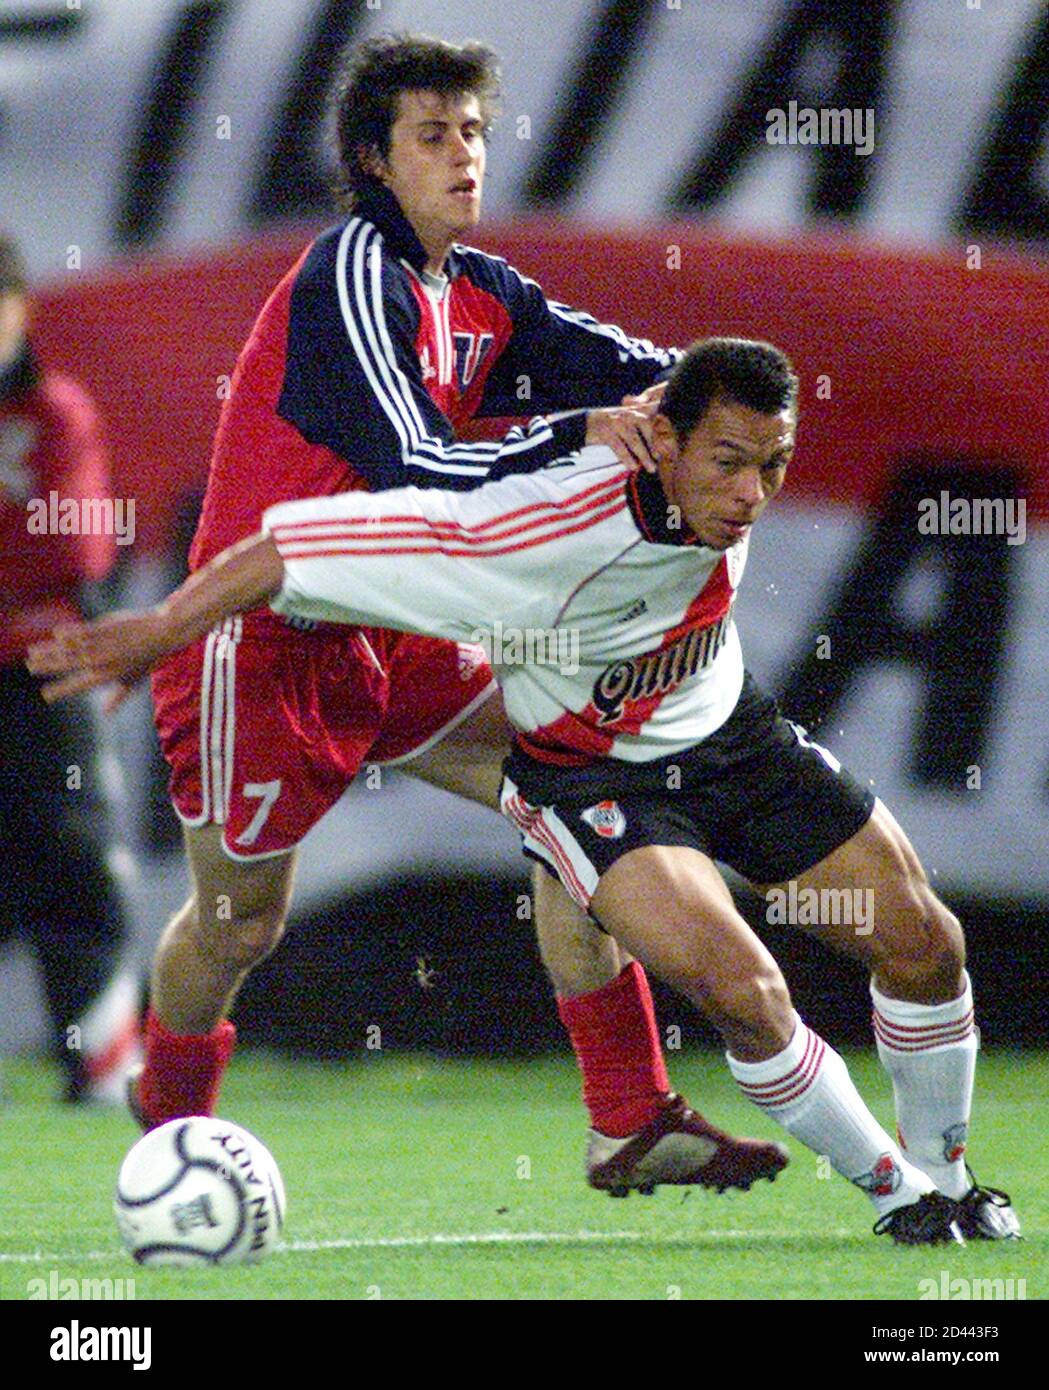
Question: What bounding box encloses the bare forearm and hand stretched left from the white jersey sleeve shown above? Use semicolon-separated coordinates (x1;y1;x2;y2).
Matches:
26;534;283;713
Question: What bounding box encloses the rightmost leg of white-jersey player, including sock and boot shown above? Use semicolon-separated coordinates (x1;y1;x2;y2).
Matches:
766;802;1020;1240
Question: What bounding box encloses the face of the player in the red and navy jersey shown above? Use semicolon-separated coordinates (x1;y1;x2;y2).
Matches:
377;92;485;254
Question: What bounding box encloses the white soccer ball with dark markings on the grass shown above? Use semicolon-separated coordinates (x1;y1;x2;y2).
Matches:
113;1115;285;1265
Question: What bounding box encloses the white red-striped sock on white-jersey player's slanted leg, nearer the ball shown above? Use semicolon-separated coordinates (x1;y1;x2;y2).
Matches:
725;1013;934;1216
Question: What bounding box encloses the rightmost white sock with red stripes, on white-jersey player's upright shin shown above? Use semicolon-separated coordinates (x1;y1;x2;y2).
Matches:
871;976;978;1197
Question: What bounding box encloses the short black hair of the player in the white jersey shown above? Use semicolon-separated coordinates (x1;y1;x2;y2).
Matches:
660;338;798;443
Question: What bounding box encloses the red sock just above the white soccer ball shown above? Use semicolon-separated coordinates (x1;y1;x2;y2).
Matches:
139;1009;236;1129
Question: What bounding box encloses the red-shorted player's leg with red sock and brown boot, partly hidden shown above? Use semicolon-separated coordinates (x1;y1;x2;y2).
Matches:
403;695;786;1197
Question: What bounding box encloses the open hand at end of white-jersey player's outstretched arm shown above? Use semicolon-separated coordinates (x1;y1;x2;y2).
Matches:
25;609;179;714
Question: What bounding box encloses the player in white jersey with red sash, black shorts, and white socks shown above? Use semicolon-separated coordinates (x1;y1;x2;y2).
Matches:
33;339;1020;1244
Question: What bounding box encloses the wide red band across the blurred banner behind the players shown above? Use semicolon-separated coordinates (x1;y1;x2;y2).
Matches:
35;220;1049;549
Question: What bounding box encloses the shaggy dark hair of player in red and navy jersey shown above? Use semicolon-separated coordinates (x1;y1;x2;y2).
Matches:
329;32;500;210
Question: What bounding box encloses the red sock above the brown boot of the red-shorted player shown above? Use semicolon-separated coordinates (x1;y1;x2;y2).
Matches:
557;960;670;1138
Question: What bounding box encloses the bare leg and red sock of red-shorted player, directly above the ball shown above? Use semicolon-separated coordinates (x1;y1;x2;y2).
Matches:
129;826;296;1127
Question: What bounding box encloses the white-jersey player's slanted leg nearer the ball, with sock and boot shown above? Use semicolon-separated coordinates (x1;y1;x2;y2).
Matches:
592;847;959;1243
